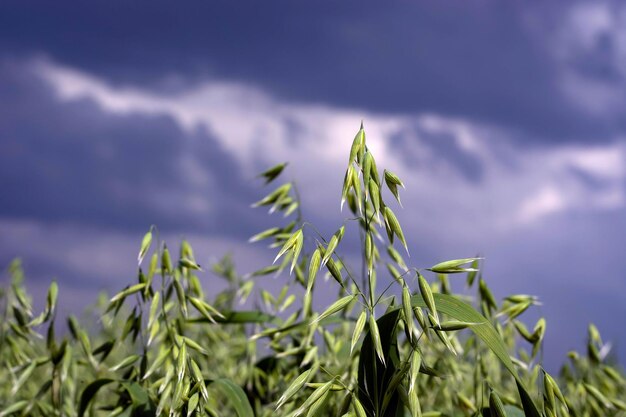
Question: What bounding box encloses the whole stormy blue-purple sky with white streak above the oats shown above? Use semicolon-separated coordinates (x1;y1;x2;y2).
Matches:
0;0;626;368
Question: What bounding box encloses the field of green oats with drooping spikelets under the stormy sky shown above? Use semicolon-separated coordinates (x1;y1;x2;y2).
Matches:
0;126;626;417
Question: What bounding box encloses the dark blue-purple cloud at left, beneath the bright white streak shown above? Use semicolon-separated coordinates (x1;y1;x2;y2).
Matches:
0;64;256;234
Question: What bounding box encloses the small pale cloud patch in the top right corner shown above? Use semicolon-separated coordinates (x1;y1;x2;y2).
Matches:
532;2;626;119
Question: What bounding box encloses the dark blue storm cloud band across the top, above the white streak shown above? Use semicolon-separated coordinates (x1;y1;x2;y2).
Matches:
0;0;624;142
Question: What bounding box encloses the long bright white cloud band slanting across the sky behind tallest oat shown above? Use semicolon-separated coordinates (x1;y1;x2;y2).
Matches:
34;60;626;240
